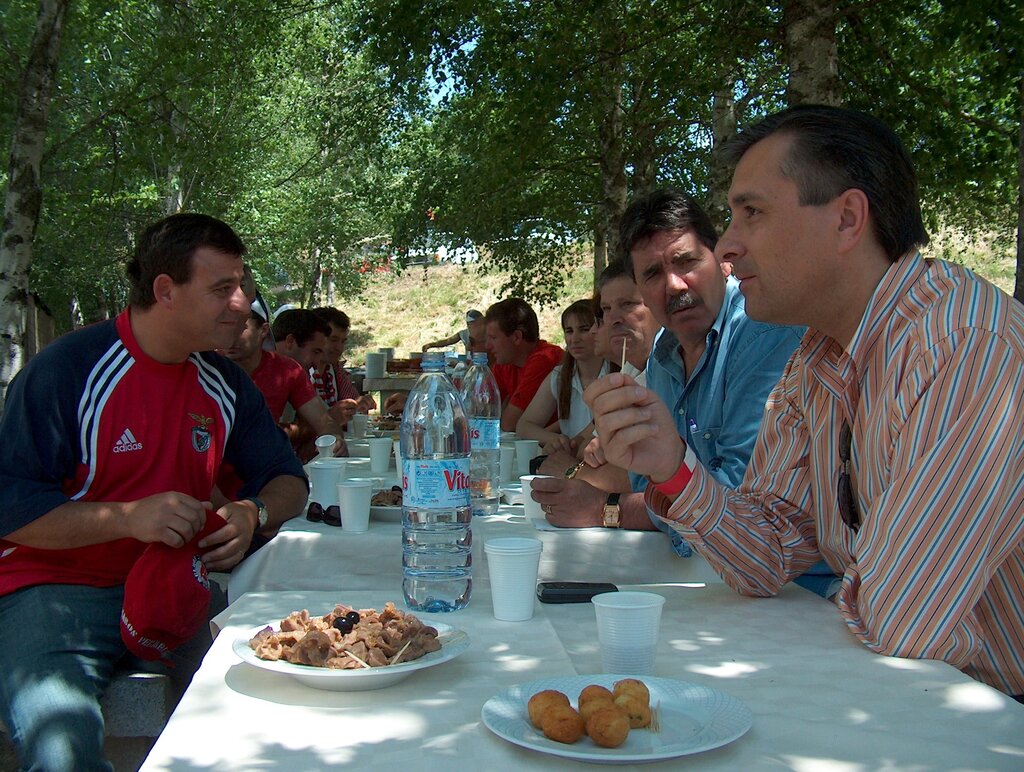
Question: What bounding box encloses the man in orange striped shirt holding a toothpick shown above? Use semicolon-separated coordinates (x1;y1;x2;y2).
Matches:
587;105;1024;697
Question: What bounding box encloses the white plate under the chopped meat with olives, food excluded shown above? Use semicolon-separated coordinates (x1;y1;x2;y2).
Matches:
231;619;469;691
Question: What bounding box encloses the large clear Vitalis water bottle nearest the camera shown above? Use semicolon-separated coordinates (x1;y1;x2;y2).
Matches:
401;352;473;611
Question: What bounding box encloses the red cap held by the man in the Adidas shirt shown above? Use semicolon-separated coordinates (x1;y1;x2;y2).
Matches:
121;511;226;659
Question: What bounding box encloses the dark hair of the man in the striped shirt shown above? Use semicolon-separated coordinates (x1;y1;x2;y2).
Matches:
724;104;928;261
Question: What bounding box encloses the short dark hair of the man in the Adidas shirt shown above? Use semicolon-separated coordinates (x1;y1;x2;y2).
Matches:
126;212;246;308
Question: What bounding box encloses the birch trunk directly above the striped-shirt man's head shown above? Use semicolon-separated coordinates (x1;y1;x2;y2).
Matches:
782;0;843;105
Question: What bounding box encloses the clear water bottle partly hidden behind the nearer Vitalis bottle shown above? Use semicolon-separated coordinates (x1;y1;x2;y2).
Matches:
462;351;502;515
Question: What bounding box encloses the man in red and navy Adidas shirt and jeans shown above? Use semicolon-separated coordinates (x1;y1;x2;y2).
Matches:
0;214;307;770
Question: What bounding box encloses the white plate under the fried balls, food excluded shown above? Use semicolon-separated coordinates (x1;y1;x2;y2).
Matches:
480;675;754;764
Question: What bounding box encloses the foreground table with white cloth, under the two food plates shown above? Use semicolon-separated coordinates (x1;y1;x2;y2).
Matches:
143;507;1024;770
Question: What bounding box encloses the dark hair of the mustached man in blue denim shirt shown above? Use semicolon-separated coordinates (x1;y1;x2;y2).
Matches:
618;187;718;278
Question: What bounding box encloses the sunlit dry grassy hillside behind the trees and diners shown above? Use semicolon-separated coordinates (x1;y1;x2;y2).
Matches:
338;233;1015;364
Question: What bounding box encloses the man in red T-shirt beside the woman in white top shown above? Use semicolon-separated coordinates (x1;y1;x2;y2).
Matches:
485;298;565;431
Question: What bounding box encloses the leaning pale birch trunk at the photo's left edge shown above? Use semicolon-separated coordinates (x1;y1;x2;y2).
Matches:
0;0;68;408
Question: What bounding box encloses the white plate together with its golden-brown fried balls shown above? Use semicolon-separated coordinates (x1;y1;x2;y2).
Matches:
481;675;754;764
